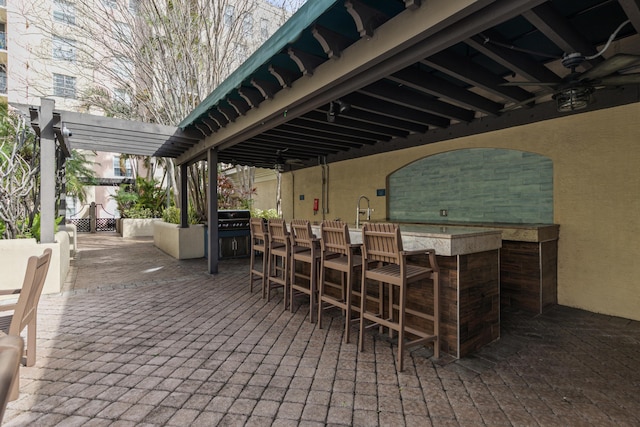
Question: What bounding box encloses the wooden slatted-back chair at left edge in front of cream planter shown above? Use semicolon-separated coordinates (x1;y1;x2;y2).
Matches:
0;248;51;399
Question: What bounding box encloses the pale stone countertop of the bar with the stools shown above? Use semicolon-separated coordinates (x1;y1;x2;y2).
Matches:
312;224;502;256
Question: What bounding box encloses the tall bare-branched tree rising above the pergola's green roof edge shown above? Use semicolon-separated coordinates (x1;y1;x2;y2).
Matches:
15;0;303;219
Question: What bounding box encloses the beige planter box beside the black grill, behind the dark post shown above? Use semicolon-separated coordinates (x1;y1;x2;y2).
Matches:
153;220;205;259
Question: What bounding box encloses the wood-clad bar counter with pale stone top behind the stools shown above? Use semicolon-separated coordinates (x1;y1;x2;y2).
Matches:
312;224;502;358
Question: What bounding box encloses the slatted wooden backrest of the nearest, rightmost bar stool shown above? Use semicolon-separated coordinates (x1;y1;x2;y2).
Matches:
362;223;402;265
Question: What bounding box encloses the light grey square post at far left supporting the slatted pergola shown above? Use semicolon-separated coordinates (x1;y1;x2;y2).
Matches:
38;98;56;243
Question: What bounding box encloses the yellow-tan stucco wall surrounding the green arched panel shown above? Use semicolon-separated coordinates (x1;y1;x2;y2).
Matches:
258;103;640;320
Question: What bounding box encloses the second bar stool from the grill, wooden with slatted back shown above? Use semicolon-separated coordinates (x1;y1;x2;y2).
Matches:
266;219;291;308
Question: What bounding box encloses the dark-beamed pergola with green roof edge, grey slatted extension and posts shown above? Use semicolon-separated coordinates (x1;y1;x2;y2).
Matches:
28;0;640;273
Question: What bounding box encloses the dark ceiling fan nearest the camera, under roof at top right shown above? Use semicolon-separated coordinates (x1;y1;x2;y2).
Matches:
500;20;640;112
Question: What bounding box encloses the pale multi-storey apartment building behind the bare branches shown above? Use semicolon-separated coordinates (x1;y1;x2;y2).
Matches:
0;0;290;217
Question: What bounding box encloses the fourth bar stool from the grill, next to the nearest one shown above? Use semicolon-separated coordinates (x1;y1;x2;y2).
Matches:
318;221;362;343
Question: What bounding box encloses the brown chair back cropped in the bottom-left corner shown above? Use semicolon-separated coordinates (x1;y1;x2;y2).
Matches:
0;335;24;412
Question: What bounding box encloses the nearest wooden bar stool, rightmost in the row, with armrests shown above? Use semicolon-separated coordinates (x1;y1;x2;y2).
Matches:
359;224;440;371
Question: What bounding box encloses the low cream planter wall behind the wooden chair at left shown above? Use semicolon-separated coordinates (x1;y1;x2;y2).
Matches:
0;231;71;294
